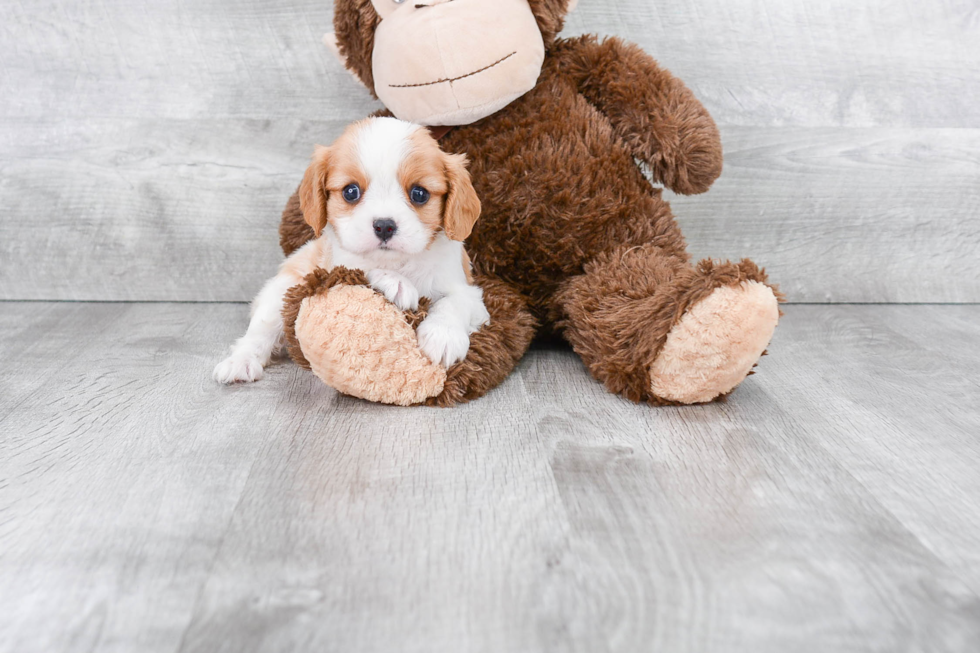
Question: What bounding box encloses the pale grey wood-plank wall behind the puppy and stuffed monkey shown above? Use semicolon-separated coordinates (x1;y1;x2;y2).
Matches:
0;0;980;302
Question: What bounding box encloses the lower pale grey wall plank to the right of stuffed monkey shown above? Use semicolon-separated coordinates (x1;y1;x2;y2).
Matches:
671;127;980;303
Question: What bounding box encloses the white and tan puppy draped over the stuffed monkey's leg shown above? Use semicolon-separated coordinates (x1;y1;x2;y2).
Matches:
214;118;490;383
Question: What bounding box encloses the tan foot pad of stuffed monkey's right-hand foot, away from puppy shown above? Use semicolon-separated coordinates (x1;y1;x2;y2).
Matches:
650;281;779;404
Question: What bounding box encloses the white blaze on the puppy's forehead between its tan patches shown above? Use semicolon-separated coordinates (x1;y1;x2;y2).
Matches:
357;118;420;198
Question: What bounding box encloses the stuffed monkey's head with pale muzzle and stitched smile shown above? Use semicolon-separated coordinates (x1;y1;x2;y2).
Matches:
325;0;576;125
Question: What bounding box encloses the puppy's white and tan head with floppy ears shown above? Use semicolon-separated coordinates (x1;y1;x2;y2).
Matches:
299;118;480;255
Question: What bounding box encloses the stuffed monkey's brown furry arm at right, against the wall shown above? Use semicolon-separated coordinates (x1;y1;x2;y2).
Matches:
552;35;722;195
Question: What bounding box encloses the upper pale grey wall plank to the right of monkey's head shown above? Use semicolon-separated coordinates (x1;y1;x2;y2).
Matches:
567;0;980;129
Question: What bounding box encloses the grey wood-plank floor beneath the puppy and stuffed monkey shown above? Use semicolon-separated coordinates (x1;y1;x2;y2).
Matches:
0;302;980;653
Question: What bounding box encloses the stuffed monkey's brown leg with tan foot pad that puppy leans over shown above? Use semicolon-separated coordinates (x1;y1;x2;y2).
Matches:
283;268;534;406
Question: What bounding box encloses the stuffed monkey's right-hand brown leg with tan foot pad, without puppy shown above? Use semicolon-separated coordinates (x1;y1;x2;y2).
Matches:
554;245;779;404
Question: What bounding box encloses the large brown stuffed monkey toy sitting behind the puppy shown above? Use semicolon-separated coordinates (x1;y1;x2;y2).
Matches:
280;0;780;406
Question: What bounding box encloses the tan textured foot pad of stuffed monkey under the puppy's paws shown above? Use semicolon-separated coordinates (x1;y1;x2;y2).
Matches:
296;285;446;406
